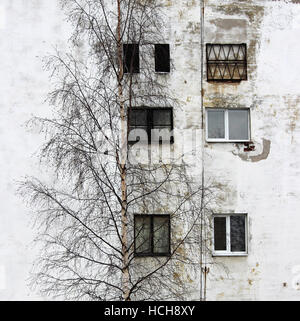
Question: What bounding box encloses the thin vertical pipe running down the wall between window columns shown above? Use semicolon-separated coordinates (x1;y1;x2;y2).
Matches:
200;0;206;301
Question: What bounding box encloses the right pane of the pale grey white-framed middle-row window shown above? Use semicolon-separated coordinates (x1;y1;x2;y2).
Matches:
228;110;249;140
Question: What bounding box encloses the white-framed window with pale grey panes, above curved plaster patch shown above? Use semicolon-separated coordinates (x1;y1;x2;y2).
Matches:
206;108;250;142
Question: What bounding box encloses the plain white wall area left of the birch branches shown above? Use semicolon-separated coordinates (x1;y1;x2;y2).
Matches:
0;0;69;300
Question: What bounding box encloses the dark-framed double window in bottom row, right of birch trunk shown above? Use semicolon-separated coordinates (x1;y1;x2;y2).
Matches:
134;215;171;256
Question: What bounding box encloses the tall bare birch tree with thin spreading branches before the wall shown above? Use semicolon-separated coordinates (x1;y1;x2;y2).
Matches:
21;0;217;301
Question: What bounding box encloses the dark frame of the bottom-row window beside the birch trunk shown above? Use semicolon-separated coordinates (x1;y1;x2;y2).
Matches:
133;214;171;257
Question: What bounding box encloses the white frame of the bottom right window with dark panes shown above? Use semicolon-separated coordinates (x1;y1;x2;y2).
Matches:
212;213;249;256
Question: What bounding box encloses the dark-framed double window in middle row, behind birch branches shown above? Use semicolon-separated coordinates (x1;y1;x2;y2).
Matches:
128;107;174;144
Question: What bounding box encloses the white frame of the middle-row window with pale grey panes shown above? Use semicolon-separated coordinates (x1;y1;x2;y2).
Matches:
205;107;251;143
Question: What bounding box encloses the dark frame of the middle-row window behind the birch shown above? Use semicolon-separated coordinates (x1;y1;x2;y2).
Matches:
127;106;174;145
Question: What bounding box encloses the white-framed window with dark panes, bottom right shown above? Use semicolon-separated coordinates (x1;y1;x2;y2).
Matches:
213;214;248;256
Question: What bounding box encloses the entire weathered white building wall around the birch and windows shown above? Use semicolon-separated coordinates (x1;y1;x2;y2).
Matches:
0;0;300;300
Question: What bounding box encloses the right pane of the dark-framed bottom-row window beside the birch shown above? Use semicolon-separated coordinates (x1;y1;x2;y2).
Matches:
153;216;170;254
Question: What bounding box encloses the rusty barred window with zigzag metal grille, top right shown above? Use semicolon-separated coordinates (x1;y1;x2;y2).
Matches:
206;43;247;82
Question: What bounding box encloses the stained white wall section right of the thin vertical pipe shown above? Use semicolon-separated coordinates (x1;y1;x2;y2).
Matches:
200;1;300;300
